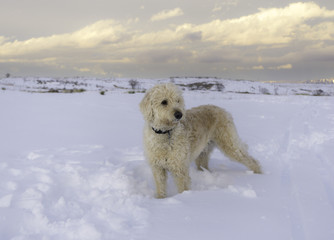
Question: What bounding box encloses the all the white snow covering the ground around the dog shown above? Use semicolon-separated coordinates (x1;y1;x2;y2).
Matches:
0;78;334;240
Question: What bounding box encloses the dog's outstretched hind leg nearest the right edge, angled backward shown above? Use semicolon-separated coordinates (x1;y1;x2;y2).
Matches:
213;112;262;173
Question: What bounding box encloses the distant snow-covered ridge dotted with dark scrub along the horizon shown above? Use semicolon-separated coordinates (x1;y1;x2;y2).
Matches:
0;77;334;96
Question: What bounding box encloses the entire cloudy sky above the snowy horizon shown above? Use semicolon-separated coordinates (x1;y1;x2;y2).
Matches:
0;0;334;81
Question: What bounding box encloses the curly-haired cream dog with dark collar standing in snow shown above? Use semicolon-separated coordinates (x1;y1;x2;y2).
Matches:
139;83;261;198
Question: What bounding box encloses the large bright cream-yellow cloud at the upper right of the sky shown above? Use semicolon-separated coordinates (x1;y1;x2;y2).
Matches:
196;2;334;46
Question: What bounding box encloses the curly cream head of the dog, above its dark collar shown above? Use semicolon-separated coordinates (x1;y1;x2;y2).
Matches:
140;83;185;131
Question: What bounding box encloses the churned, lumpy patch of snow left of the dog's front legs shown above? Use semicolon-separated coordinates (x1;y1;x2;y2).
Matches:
0;145;153;239
